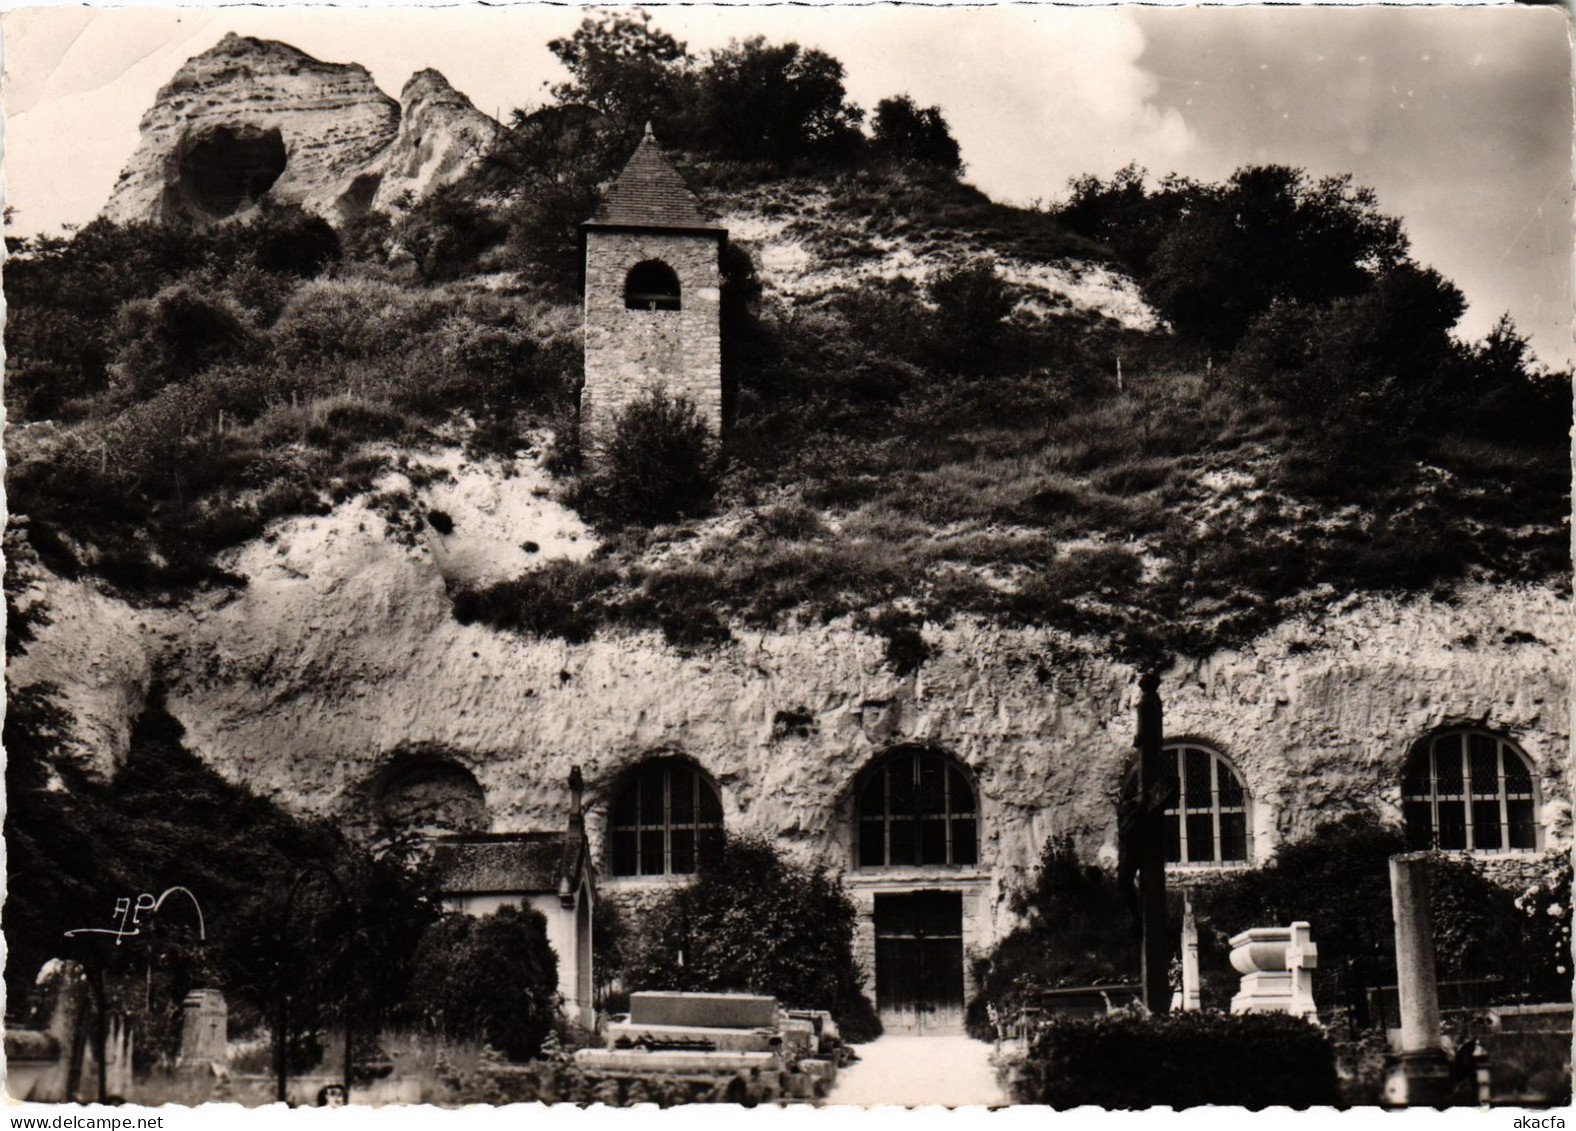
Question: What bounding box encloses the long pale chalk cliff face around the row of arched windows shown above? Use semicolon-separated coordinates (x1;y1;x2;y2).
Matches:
14;455;1571;945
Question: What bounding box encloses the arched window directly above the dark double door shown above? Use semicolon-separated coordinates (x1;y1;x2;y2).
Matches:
859;748;979;868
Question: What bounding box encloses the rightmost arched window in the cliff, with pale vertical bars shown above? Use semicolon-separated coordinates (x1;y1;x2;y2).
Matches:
1401;729;1538;852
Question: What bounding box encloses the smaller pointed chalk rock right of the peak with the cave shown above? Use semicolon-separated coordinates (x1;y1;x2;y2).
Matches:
358;68;500;211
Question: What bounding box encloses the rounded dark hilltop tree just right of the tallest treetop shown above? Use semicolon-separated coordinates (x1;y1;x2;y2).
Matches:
698;36;864;165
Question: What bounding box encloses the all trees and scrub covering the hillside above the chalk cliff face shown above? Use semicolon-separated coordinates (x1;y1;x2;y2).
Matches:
5;16;1570;674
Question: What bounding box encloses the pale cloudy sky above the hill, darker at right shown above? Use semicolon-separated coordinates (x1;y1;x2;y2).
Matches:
0;5;1576;365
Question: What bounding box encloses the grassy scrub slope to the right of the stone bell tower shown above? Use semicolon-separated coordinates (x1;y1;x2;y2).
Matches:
450;166;1568;658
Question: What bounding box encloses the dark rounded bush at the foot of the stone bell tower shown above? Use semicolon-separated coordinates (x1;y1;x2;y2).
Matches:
589;388;720;526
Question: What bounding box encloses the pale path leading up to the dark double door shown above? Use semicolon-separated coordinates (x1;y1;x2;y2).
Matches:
826;1036;1007;1107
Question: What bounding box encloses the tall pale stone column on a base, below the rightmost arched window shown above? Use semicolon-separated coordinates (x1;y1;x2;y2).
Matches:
1384;852;1450;1107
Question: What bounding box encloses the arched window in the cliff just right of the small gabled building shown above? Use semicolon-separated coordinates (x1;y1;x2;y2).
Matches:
608;758;722;876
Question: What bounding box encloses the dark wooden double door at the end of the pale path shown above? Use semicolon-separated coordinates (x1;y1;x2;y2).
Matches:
875;892;963;1033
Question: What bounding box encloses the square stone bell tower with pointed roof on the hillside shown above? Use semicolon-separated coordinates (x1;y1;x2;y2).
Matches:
580;124;728;452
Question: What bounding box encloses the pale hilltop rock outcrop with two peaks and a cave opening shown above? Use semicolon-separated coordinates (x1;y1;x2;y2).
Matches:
104;33;496;225
